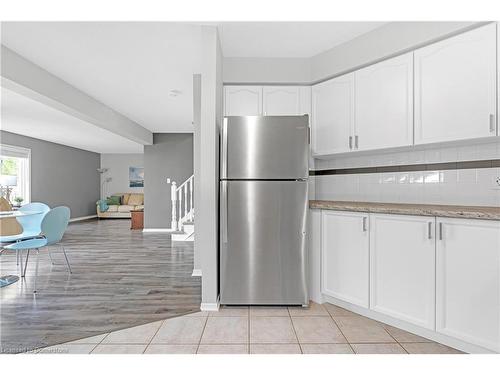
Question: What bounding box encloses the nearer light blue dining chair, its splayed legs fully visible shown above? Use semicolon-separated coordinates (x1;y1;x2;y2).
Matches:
0;206;72;293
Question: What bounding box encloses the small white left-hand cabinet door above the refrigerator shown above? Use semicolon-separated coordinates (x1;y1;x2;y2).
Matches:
224;86;262;116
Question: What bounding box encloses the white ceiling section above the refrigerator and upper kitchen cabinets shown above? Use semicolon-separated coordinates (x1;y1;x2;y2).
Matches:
219;22;384;58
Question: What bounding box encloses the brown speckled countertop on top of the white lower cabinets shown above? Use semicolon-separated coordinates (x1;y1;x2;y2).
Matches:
309;200;500;220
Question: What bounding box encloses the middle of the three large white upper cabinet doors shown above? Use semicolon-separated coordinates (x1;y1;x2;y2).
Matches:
354;53;413;150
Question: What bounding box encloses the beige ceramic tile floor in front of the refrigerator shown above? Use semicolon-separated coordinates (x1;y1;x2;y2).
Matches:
34;303;460;354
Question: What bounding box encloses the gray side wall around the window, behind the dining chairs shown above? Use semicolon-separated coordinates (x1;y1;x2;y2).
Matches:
0;131;100;218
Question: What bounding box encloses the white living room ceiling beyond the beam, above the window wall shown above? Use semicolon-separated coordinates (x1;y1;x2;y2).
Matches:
1;88;143;153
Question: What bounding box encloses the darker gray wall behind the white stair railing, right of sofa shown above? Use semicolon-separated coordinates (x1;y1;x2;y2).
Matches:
144;133;196;229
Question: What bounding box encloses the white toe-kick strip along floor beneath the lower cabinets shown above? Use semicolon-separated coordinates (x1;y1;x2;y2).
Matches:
323;294;494;354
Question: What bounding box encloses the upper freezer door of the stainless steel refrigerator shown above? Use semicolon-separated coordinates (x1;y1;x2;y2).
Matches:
221;115;309;179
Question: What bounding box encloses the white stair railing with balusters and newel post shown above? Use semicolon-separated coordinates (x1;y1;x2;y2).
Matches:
170;175;194;230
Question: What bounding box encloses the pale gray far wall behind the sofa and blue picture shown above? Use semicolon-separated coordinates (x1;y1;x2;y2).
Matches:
101;154;144;197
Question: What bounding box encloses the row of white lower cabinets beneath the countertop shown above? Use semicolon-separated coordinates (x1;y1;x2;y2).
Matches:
316;210;500;353
